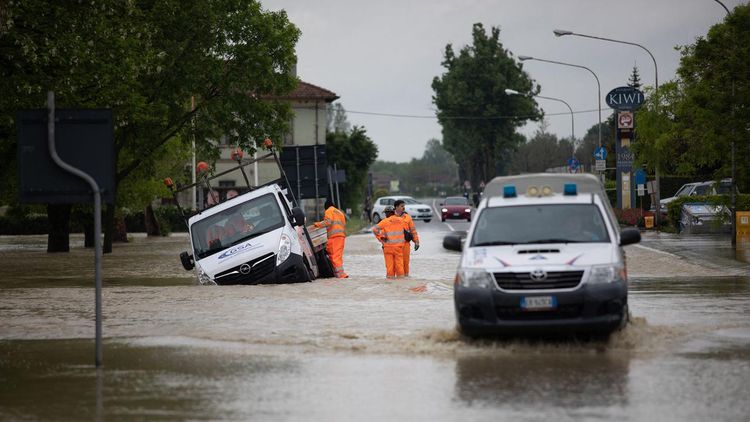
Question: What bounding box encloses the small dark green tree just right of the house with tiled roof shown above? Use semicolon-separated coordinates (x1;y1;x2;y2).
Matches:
326;126;378;211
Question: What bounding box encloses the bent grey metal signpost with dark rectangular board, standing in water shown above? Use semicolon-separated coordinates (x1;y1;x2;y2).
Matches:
16;91;115;368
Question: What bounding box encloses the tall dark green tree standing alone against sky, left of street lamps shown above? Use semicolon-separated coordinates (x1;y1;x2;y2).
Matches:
432;23;541;186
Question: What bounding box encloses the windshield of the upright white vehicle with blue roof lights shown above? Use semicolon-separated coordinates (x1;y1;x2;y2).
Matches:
471;204;609;246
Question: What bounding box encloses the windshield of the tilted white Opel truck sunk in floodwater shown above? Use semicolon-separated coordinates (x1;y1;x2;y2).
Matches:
190;193;284;259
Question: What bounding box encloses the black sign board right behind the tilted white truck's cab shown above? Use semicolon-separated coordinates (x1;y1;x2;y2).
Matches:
279;145;328;199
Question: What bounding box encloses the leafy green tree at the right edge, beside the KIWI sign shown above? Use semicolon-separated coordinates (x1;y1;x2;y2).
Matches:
634;4;750;192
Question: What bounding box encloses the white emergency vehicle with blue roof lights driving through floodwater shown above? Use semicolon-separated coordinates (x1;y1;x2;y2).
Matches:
444;173;640;336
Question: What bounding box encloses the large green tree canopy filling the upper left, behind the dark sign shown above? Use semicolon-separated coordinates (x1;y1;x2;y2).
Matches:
0;0;299;251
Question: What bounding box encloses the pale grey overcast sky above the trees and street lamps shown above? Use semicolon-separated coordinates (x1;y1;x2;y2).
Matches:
261;0;745;162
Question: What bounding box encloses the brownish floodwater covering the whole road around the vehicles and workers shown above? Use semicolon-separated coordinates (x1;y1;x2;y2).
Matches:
0;221;750;421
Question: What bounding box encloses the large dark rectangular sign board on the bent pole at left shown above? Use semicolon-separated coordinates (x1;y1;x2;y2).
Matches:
16;109;115;204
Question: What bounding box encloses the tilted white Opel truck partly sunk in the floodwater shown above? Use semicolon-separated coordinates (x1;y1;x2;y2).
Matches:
172;143;333;285
